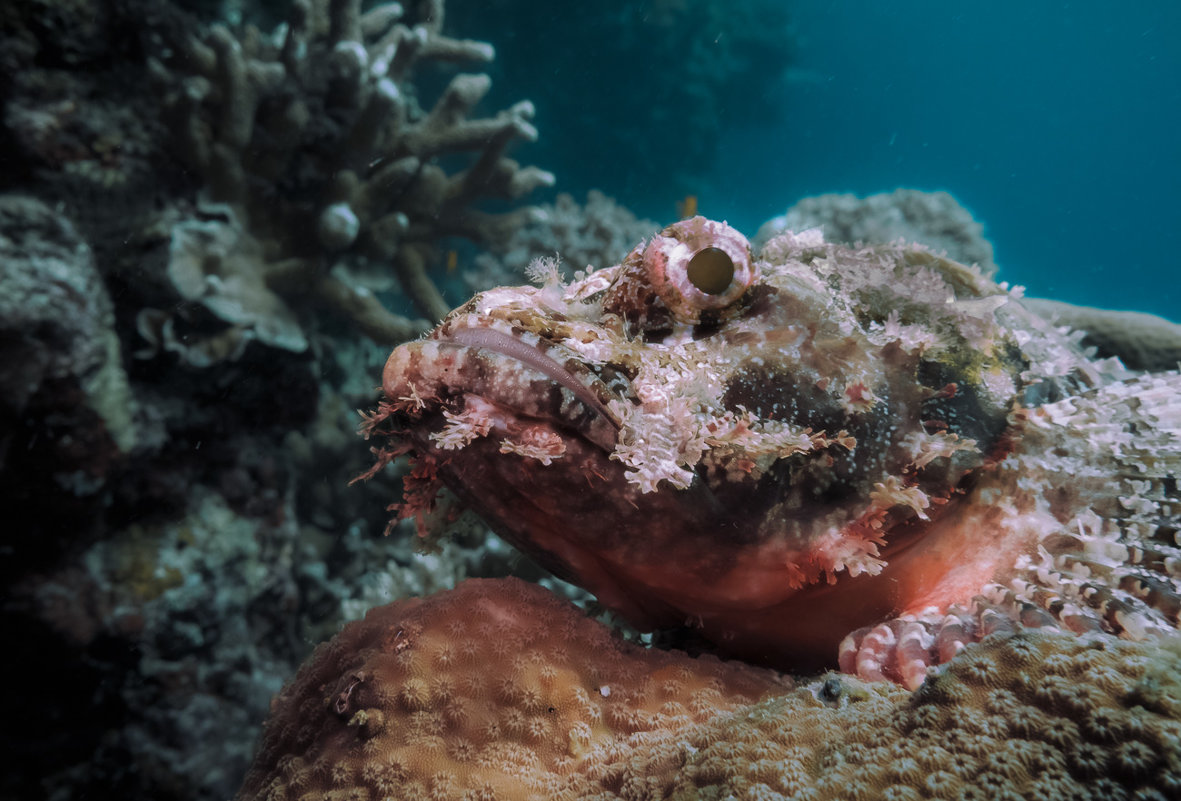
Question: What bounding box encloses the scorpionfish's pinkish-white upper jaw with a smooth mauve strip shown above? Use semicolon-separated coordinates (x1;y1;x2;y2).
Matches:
381;314;627;455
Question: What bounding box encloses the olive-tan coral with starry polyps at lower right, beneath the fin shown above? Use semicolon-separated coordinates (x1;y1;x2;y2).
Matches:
614;632;1181;801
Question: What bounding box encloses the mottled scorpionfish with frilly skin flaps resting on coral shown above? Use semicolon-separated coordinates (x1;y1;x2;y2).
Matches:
365;217;1181;686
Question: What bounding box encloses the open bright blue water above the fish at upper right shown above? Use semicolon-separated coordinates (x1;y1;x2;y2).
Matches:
700;0;1181;320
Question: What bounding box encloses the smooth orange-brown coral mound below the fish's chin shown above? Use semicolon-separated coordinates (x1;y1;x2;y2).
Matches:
239;579;783;800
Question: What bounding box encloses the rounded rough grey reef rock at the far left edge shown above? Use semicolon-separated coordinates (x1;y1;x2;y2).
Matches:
0;195;137;574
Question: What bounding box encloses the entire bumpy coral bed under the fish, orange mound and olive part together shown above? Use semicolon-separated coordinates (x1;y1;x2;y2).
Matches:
239;579;1181;801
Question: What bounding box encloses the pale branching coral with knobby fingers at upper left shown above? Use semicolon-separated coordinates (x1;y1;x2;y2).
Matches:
141;0;553;352
